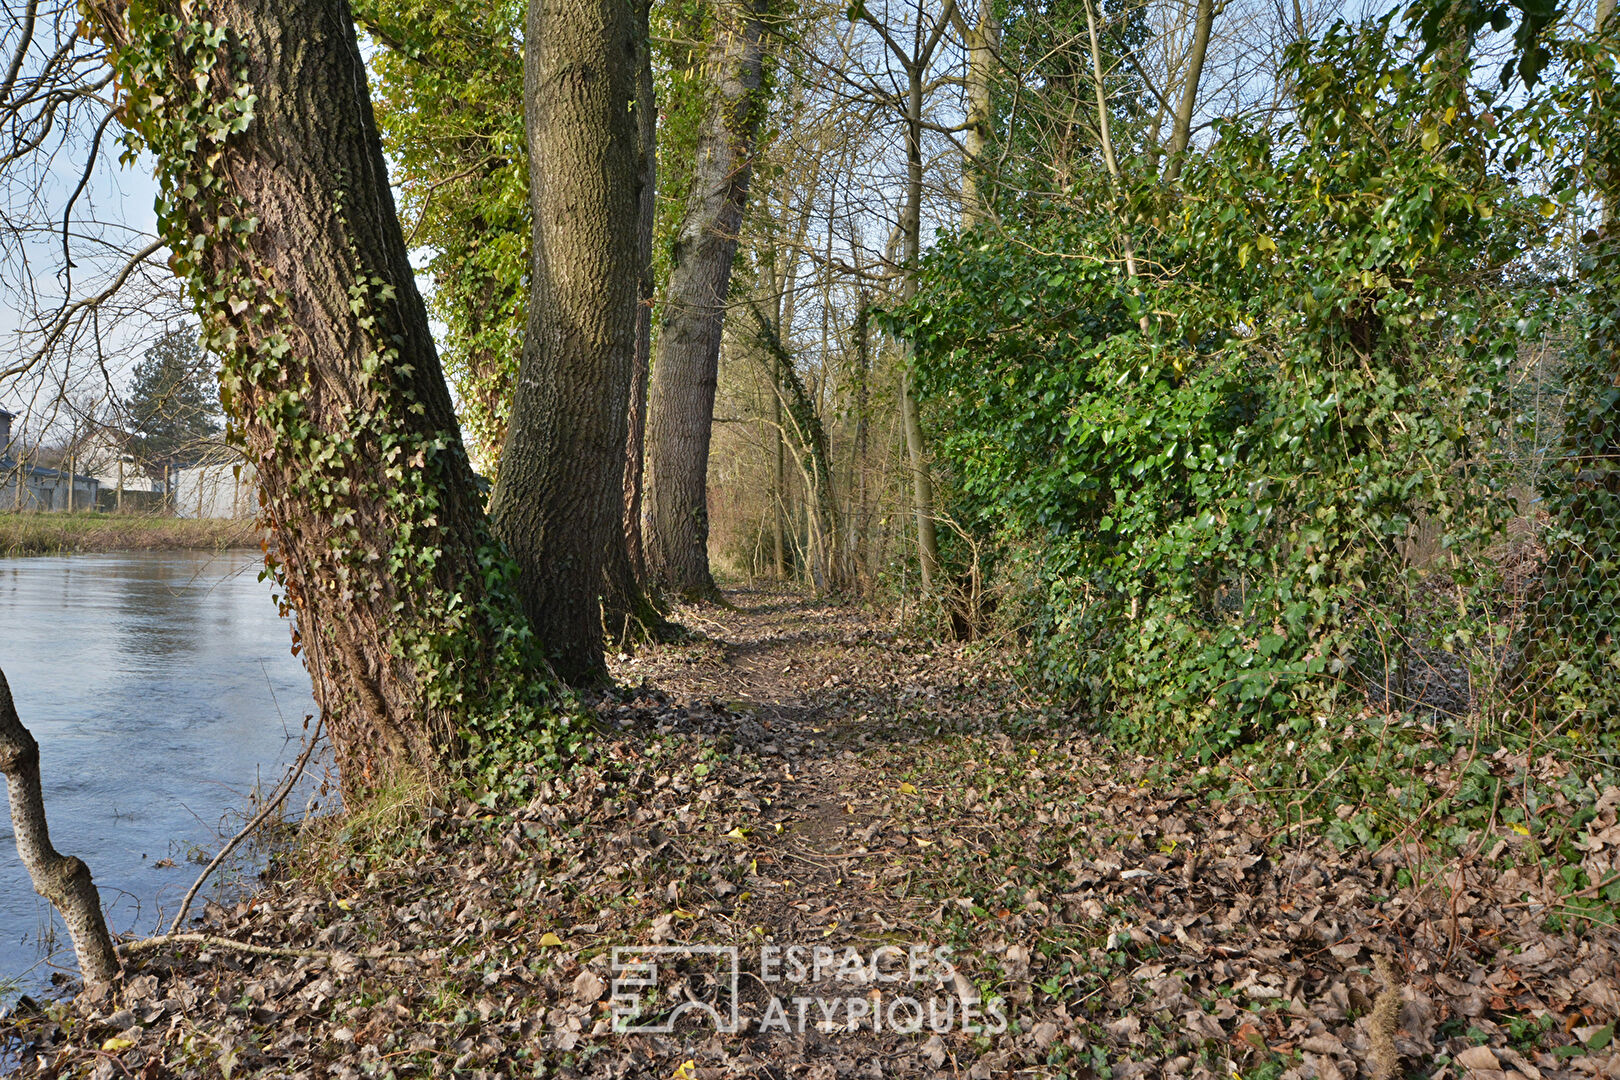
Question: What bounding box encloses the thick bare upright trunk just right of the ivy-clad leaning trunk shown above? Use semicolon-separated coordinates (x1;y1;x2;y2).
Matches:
491;0;645;682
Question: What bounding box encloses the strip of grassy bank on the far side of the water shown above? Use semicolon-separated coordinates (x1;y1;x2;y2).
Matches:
0;513;259;555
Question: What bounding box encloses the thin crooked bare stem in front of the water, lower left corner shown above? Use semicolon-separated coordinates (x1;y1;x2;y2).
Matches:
0;672;122;984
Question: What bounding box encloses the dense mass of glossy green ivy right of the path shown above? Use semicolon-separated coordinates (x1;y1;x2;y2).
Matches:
896;19;1545;755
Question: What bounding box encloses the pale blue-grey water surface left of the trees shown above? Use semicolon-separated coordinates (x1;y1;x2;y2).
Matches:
0;551;314;1002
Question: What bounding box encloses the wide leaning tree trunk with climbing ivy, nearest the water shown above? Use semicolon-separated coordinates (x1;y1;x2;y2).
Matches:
89;0;570;798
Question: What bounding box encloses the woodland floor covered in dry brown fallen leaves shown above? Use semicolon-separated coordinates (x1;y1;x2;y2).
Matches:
0;591;1620;1080
